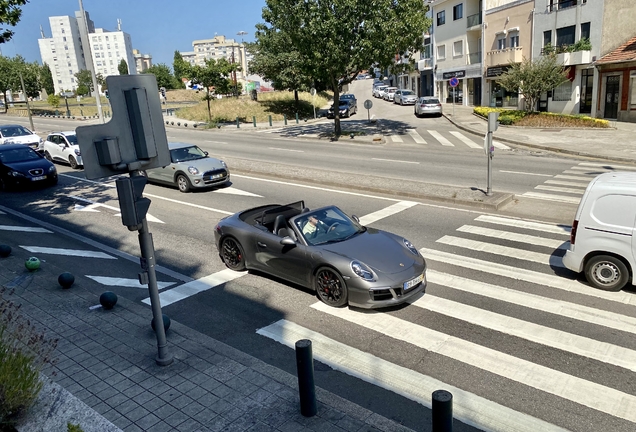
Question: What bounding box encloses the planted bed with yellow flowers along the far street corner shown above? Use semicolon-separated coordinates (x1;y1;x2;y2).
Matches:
473;107;610;129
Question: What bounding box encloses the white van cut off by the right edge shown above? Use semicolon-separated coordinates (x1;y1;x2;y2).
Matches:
563;172;636;291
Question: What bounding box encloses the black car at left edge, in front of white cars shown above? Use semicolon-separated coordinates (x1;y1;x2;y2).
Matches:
0;144;57;190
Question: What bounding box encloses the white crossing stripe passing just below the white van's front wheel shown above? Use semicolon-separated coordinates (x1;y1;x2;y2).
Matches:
420;248;636;305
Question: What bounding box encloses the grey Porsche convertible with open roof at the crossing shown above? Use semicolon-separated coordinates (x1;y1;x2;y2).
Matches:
214;201;426;309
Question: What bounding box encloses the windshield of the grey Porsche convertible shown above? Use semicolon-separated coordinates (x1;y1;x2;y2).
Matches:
294;207;365;246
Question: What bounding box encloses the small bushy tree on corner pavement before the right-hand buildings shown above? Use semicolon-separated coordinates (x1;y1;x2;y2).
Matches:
498;53;568;111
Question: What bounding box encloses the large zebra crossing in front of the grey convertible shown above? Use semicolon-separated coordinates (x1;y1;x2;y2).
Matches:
257;213;636;432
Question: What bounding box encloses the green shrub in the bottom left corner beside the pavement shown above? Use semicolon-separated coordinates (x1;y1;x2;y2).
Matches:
0;288;57;430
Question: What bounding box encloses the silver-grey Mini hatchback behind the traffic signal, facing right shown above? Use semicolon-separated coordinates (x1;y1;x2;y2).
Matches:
145;143;230;192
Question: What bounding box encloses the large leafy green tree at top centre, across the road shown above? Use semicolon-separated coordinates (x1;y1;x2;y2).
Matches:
257;0;431;135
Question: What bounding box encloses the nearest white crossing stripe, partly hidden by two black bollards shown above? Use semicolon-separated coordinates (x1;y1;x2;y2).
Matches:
256;320;566;432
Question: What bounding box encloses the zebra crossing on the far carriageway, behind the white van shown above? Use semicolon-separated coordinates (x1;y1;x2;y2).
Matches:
521;162;636;204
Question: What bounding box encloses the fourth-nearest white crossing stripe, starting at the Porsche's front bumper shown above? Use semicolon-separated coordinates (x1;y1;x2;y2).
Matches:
426;269;636;334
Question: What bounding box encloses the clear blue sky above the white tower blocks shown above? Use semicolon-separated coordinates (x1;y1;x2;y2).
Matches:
0;0;265;68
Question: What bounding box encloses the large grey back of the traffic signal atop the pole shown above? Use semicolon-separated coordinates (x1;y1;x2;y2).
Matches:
76;74;170;179
